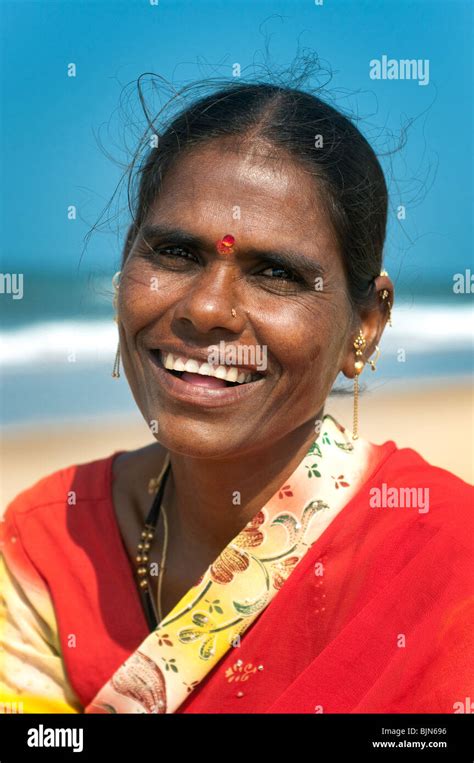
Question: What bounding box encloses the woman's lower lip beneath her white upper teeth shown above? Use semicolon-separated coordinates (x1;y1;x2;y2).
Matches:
148;350;265;408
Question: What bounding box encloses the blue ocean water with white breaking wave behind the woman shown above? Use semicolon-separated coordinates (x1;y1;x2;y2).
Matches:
0;275;474;428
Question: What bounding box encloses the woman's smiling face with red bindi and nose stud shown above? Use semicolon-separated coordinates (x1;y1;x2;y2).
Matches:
118;141;353;458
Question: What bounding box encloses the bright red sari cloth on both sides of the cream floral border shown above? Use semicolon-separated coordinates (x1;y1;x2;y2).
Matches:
0;442;474;713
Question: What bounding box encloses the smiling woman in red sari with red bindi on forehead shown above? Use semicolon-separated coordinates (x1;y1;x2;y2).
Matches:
0;83;473;713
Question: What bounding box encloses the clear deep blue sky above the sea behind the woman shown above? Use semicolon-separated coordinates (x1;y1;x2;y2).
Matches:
0;0;473;290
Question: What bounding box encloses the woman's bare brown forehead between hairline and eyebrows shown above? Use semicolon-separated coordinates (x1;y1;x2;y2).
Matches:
154;144;332;236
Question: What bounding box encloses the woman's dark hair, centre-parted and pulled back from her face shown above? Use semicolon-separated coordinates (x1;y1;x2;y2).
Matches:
121;82;388;309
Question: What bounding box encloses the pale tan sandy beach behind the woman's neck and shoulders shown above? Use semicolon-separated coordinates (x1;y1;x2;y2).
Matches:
0;381;474;513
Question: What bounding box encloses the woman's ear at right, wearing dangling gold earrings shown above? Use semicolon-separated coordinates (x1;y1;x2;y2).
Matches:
341;274;394;379
